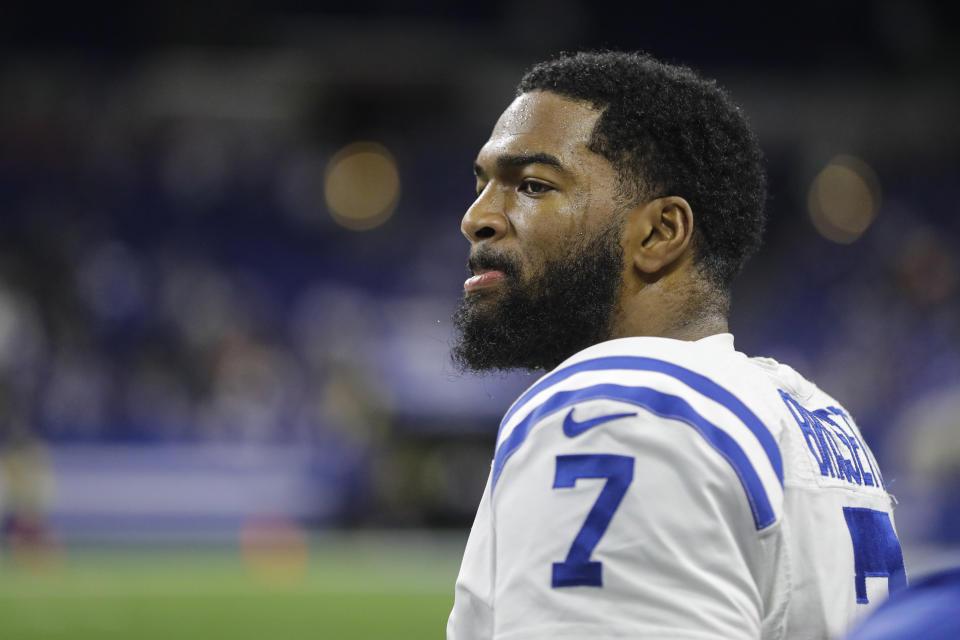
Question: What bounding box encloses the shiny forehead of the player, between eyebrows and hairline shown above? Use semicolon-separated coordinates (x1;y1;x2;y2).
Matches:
478;91;601;164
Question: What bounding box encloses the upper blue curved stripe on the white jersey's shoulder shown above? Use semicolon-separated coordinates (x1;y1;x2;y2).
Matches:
497;356;783;485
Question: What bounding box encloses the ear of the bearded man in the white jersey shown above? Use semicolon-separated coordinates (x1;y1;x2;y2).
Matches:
624;196;693;274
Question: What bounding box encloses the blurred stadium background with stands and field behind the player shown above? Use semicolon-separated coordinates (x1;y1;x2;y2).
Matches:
0;0;960;639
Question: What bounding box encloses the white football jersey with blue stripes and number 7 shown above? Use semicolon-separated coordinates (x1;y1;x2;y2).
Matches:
447;334;906;640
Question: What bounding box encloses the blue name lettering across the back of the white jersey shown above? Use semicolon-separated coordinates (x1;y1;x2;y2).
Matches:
780;390;882;487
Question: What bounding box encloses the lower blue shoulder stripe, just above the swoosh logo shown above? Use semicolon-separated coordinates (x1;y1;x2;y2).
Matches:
491;384;776;529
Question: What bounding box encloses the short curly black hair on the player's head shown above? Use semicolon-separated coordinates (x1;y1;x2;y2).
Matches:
517;51;767;291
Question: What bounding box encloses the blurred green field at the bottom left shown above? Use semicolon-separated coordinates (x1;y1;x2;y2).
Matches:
0;536;464;640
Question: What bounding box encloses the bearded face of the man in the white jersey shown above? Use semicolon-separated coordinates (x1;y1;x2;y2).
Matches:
453;92;625;370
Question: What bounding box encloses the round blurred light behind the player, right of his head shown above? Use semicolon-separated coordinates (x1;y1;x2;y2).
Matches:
807;155;880;244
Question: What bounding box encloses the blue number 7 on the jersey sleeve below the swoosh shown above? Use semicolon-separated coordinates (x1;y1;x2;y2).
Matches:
551;454;633;588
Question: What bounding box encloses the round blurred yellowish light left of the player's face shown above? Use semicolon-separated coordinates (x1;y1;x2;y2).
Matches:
324;142;400;231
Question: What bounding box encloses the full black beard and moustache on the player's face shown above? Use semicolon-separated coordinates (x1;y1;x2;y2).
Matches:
452;224;623;372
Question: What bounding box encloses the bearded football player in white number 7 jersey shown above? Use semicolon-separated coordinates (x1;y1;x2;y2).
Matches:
447;52;906;640
